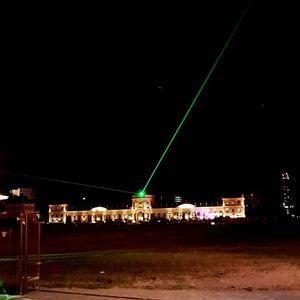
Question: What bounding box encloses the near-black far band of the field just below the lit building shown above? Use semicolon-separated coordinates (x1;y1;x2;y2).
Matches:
41;223;300;253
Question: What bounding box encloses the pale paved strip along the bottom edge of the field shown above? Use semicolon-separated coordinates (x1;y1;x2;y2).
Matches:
0;288;300;300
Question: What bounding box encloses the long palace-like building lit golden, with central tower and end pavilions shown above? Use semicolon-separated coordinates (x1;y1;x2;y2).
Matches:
48;195;246;223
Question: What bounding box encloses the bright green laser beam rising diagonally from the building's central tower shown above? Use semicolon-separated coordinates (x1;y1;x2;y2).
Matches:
142;6;249;192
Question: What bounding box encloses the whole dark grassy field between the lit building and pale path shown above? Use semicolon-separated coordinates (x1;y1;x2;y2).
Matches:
0;223;300;289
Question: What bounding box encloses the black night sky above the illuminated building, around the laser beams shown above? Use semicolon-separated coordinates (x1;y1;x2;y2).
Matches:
0;0;300;206
